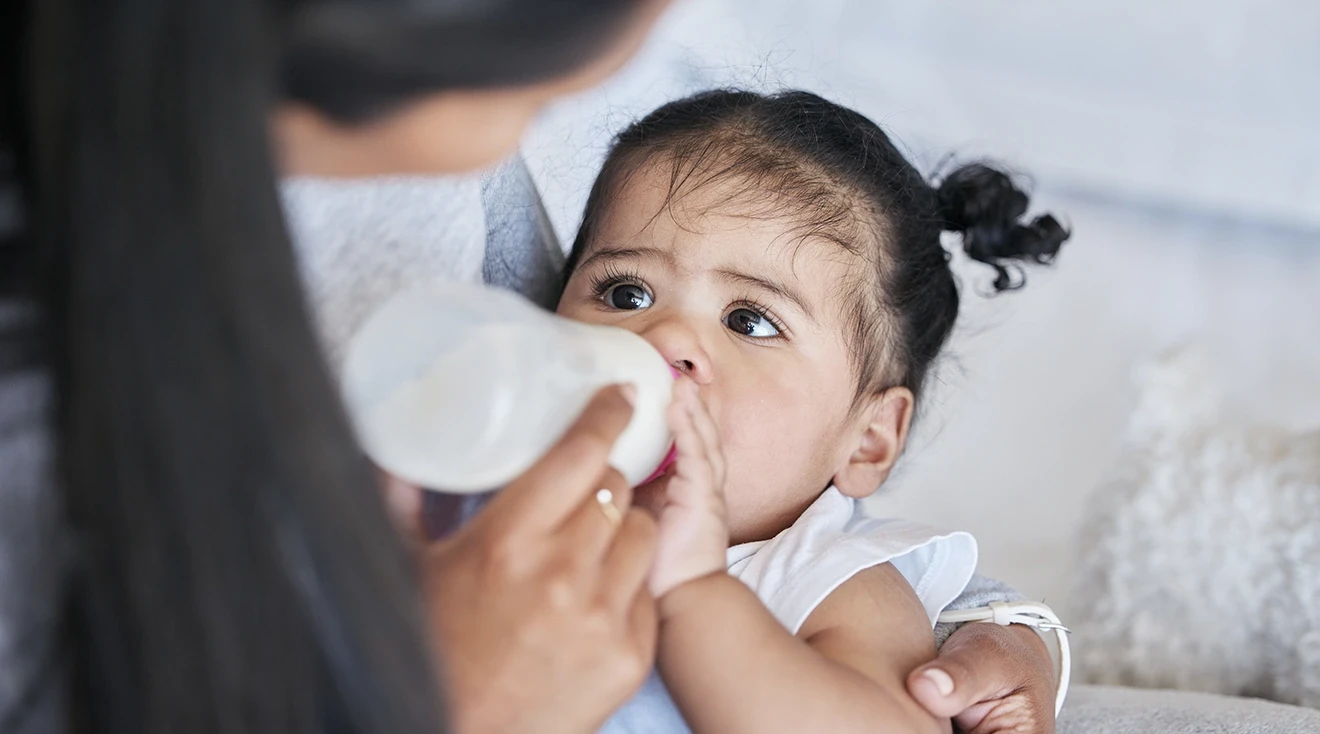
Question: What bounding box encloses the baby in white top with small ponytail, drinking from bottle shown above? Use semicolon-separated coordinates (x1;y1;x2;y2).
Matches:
558;91;1068;733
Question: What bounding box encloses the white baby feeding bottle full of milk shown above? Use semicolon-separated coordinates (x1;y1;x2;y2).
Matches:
341;283;673;492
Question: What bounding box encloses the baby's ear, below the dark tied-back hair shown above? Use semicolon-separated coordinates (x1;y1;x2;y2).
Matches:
834;387;916;499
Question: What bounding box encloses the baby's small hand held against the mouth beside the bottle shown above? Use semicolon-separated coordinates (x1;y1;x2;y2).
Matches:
639;378;729;598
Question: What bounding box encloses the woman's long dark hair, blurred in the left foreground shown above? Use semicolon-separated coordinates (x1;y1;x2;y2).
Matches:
0;0;636;733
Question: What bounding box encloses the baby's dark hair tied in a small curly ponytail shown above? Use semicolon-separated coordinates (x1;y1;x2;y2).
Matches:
568;90;1069;406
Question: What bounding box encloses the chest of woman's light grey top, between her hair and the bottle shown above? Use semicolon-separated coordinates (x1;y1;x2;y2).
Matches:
282;157;564;368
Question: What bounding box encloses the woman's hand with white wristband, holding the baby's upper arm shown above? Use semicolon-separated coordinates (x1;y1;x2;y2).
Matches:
907;623;1055;734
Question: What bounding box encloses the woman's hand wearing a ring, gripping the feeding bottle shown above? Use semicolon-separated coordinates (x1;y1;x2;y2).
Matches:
422;388;656;733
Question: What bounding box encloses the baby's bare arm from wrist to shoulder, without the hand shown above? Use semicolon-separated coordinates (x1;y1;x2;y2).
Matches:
657;564;950;733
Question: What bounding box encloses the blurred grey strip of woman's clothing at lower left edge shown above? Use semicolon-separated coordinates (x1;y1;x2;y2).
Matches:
0;304;67;733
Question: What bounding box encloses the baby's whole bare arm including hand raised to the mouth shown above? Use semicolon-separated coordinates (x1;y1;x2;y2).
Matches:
651;380;950;734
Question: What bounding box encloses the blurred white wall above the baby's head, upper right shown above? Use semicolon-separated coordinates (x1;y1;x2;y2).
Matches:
525;0;1320;231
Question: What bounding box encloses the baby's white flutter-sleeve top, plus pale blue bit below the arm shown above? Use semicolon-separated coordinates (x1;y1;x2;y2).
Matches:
601;487;977;734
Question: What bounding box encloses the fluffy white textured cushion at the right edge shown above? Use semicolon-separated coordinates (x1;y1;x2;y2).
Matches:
1069;350;1320;708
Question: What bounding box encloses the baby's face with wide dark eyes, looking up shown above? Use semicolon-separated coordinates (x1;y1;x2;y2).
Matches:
558;169;861;543
